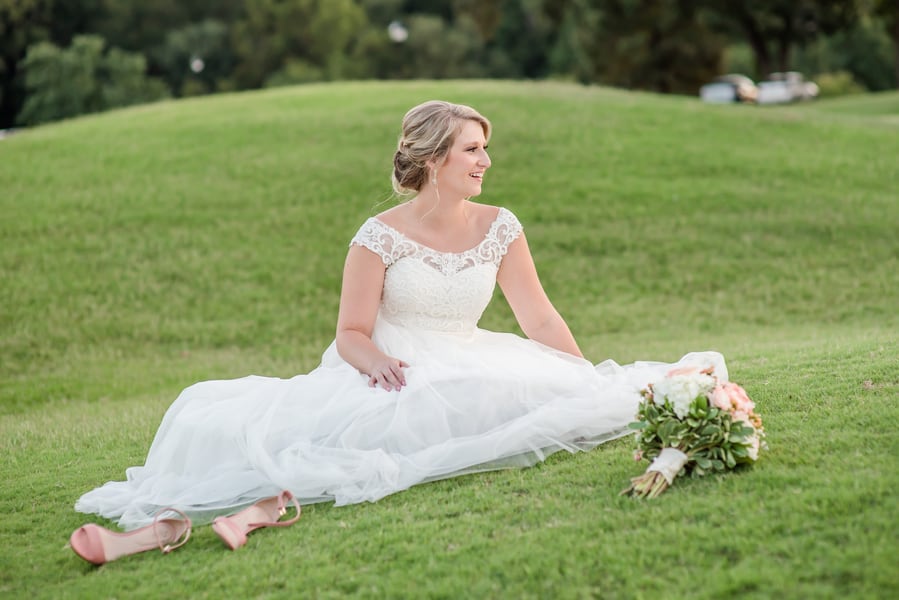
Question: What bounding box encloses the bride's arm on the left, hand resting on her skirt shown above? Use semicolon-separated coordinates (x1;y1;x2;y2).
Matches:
336;245;409;391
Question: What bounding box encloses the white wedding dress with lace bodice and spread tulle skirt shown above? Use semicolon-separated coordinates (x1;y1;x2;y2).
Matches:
75;209;727;529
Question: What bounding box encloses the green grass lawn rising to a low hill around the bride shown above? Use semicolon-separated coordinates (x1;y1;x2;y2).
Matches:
0;82;899;598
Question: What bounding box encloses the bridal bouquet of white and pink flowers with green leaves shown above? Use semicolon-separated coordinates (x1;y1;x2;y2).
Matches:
621;367;767;498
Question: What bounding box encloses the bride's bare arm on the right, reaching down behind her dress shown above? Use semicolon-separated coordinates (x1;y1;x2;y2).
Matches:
496;233;584;358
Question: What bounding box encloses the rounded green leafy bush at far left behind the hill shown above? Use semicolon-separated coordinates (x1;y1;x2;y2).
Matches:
18;36;167;125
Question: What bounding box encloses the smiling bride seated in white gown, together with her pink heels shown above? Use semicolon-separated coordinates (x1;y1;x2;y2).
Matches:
71;101;726;564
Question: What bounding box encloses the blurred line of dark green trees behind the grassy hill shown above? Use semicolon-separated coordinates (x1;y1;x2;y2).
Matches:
0;0;899;128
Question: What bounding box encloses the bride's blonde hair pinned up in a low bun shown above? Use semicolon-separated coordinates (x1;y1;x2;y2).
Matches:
391;100;491;196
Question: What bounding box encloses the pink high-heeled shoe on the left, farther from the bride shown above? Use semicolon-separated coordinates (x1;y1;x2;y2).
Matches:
69;508;191;565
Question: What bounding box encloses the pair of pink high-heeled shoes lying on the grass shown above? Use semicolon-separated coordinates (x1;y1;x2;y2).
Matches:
69;490;301;565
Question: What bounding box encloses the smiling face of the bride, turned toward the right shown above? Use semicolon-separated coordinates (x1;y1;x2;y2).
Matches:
437;121;490;198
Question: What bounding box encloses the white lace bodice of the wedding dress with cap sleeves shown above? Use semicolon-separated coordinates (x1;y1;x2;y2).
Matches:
350;208;522;332
